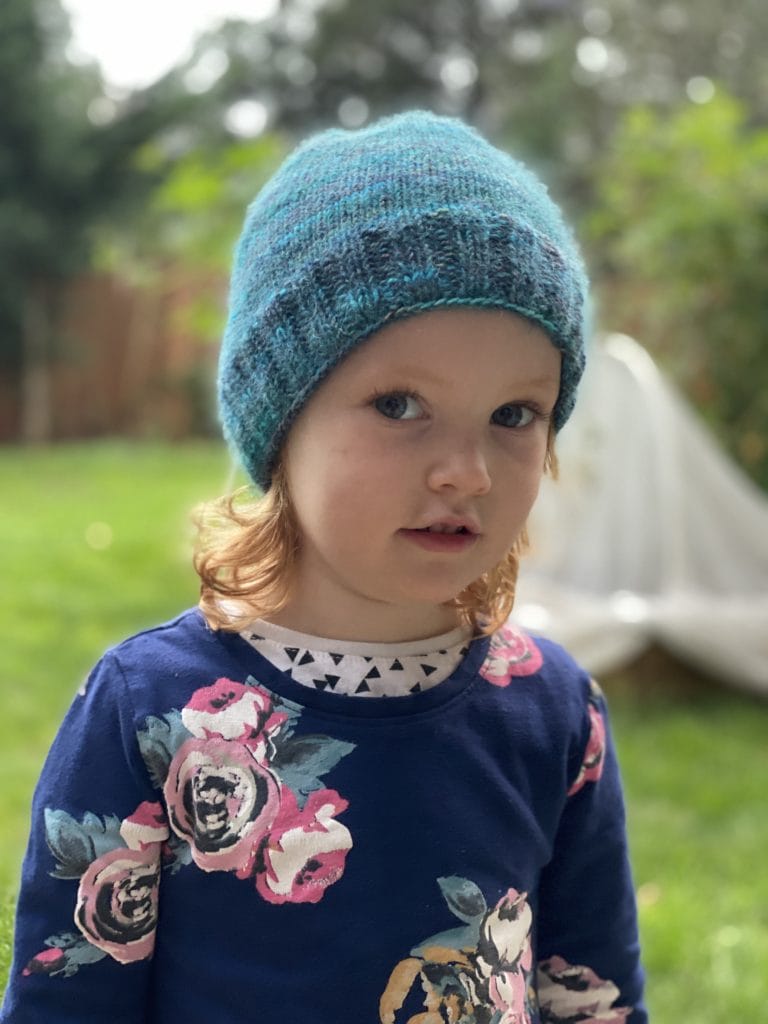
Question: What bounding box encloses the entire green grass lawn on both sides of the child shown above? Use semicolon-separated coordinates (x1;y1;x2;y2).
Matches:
0;442;768;1024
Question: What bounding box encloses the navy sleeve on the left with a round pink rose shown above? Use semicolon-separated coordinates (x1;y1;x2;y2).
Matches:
0;654;162;1024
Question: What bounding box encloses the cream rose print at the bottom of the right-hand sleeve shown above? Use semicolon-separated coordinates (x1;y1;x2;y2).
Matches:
537;956;631;1024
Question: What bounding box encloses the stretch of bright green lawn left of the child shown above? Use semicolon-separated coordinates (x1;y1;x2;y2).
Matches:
0;442;229;889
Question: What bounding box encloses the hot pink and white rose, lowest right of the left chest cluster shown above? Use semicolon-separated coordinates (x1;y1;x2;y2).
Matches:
256;790;352;903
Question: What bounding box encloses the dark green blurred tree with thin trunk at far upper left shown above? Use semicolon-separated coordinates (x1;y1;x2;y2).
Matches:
0;0;205;440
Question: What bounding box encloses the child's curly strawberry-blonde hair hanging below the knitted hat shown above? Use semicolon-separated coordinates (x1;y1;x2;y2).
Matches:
194;427;557;634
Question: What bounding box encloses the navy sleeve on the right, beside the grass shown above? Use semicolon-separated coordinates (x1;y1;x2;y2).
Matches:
537;682;647;1024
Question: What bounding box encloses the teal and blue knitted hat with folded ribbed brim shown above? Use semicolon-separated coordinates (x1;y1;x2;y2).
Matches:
219;111;587;487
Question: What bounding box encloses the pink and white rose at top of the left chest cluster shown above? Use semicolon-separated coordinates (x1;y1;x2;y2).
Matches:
181;678;288;761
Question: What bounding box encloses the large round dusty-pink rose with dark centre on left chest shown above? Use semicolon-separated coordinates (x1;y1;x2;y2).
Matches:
164;738;281;871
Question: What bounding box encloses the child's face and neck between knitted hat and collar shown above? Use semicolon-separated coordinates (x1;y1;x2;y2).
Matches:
280;308;560;641
